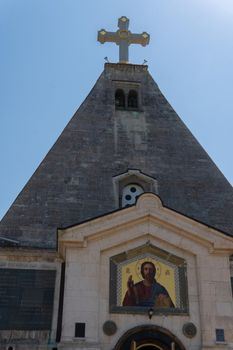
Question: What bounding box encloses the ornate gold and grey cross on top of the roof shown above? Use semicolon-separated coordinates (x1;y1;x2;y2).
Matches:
98;16;150;63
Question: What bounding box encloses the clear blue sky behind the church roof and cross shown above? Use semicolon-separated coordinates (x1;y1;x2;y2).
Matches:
0;0;233;217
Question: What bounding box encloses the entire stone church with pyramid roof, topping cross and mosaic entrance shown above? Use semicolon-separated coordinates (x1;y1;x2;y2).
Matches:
0;16;233;350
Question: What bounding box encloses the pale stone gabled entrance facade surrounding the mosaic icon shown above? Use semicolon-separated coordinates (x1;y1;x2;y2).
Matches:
59;194;233;350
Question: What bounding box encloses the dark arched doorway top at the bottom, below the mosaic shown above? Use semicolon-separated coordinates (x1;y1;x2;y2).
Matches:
114;325;185;350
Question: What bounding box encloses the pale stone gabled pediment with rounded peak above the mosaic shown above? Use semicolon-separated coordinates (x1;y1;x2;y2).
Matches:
58;193;233;257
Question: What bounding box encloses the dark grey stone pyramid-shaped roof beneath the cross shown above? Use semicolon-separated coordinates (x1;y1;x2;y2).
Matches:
0;64;233;249
